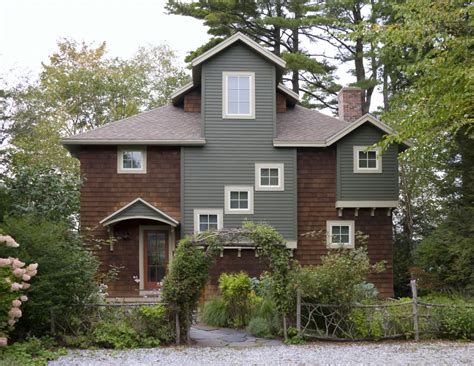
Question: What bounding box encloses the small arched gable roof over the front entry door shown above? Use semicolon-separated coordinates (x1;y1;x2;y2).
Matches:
100;198;179;227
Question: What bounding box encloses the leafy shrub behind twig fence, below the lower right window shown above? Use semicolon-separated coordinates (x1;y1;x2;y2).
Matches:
292;247;384;305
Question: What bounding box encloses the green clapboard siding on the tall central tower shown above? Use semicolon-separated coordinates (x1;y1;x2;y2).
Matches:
182;45;297;240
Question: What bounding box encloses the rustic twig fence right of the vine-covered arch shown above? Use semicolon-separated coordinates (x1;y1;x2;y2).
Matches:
296;280;474;341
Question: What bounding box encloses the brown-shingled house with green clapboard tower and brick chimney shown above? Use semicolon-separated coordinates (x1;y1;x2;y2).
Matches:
63;33;408;297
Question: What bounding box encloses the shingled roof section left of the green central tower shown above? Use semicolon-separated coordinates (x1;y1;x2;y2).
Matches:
61;104;206;150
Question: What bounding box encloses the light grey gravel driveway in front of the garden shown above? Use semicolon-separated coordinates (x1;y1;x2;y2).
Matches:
49;342;474;366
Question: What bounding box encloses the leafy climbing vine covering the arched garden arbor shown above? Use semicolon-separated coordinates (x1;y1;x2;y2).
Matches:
162;222;294;341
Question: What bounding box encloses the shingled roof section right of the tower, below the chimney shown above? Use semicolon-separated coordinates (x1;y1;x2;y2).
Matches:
273;105;411;147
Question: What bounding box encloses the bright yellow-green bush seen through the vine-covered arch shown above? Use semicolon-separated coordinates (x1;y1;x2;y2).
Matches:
219;272;255;328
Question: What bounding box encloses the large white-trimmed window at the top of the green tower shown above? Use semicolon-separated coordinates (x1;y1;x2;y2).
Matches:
222;72;255;119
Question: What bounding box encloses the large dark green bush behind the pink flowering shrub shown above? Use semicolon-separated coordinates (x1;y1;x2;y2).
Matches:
0;216;98;335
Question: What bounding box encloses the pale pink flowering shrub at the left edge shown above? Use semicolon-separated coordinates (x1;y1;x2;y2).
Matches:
0;235;38;346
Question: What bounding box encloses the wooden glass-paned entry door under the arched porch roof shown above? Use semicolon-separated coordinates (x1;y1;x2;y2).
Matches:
143;230;168;289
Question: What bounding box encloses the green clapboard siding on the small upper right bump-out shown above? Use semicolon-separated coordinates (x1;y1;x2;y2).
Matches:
337;124;398;201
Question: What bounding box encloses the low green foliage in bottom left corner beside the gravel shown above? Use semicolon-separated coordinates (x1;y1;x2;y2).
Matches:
0;337;67;366
